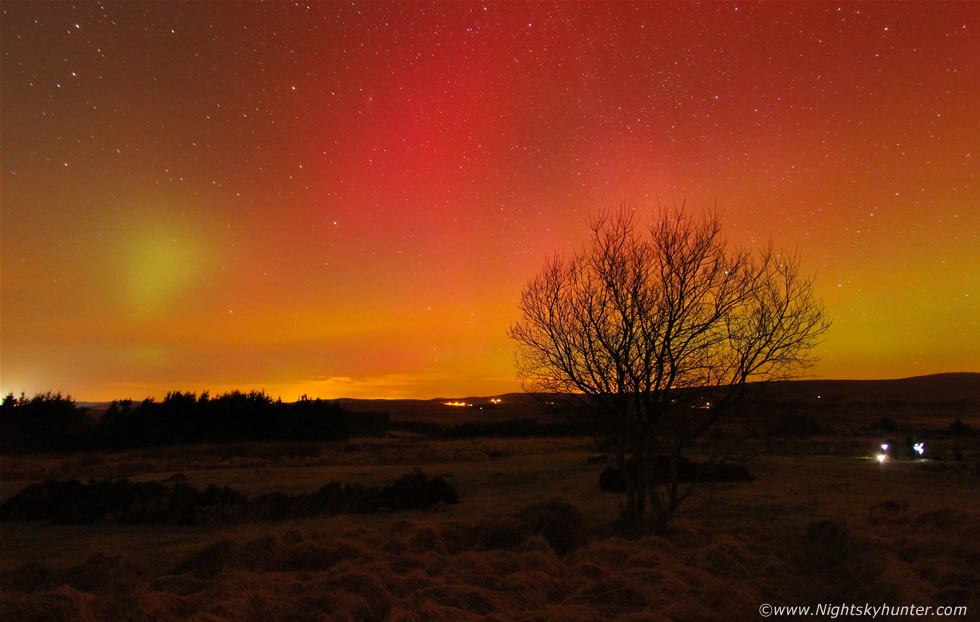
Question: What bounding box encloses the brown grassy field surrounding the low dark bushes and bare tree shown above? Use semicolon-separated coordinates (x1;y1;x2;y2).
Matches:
0;428;980;621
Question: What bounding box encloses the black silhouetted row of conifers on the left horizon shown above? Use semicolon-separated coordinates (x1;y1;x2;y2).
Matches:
0;391;388;453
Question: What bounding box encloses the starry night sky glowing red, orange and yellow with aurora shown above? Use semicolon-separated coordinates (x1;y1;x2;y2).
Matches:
0;1;980;401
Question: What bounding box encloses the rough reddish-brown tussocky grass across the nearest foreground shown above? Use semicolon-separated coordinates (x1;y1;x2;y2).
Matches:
0;504;980;622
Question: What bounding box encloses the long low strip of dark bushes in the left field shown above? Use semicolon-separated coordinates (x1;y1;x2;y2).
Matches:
0;469;459;525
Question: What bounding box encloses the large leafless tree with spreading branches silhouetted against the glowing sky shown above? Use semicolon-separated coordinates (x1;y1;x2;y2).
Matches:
509;205;830;533
